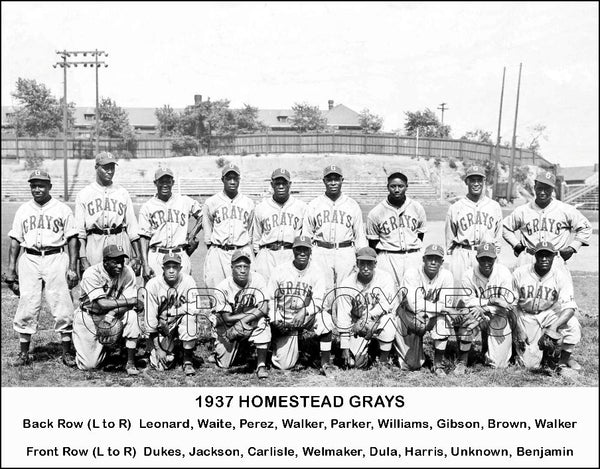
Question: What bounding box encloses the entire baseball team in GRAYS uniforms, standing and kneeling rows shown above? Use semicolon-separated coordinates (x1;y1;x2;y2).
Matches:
4;152;592;379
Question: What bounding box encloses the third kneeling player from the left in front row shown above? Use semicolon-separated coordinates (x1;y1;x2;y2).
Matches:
210;250;271;379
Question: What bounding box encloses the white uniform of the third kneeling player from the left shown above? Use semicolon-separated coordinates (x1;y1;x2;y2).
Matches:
210;272;271;368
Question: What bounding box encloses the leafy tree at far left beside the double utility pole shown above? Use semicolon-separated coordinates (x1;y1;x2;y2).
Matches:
11;78;75;137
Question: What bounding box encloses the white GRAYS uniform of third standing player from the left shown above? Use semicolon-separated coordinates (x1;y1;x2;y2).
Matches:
139;194;202;276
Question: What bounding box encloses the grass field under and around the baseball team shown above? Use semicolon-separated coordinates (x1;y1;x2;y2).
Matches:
1;199;598;386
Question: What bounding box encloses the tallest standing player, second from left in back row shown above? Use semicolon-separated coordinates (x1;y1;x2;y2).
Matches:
75;151;148;274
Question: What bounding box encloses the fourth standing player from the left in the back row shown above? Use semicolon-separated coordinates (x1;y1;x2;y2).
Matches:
202;163;254;288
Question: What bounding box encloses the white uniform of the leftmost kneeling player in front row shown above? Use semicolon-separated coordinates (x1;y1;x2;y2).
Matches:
73;262;143;370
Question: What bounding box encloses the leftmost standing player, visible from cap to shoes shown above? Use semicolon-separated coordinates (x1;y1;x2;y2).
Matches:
5;170;78;366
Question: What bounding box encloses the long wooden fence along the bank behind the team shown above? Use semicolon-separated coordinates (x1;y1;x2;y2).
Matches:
1;133;554;168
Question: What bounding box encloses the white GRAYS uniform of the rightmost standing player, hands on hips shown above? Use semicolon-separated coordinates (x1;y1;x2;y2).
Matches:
503;200;592;265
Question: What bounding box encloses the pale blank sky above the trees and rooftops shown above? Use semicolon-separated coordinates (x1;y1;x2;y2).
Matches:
1;2;599;166
